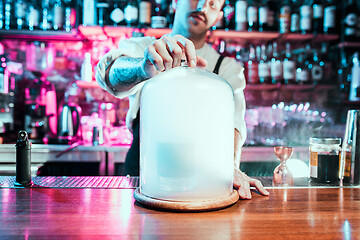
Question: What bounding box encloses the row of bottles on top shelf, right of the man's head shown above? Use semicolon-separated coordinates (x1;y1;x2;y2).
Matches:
222;0;339;34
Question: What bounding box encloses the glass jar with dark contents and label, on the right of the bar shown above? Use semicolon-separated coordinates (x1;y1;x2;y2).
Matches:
310;138;341;183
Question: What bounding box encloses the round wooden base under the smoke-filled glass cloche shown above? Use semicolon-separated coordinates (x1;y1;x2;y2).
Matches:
134;188;239;212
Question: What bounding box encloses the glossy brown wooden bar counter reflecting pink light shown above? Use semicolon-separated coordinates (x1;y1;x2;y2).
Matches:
0;177;360;240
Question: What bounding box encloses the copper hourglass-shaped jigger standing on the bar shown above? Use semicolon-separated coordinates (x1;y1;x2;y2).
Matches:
273;146;294;186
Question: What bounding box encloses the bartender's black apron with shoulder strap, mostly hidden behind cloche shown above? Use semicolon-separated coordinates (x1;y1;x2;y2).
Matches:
123;55;224;176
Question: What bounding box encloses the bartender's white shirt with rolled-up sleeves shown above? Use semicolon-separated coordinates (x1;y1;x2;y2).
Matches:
95;37;246;145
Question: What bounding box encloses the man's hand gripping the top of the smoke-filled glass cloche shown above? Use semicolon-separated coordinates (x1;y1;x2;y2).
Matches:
143;35;207;78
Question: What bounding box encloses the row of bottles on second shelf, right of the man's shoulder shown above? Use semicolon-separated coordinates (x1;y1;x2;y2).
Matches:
236;42;333;84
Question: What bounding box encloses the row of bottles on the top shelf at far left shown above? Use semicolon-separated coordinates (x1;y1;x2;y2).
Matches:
0;0;77;32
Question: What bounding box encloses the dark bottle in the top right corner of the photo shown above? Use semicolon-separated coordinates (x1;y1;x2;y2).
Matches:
343;0;358;41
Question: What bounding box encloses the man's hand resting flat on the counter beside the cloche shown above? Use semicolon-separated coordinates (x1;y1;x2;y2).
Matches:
234;169;269;199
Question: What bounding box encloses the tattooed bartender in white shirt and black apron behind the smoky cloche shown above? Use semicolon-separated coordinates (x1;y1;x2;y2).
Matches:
96;0;269;199
